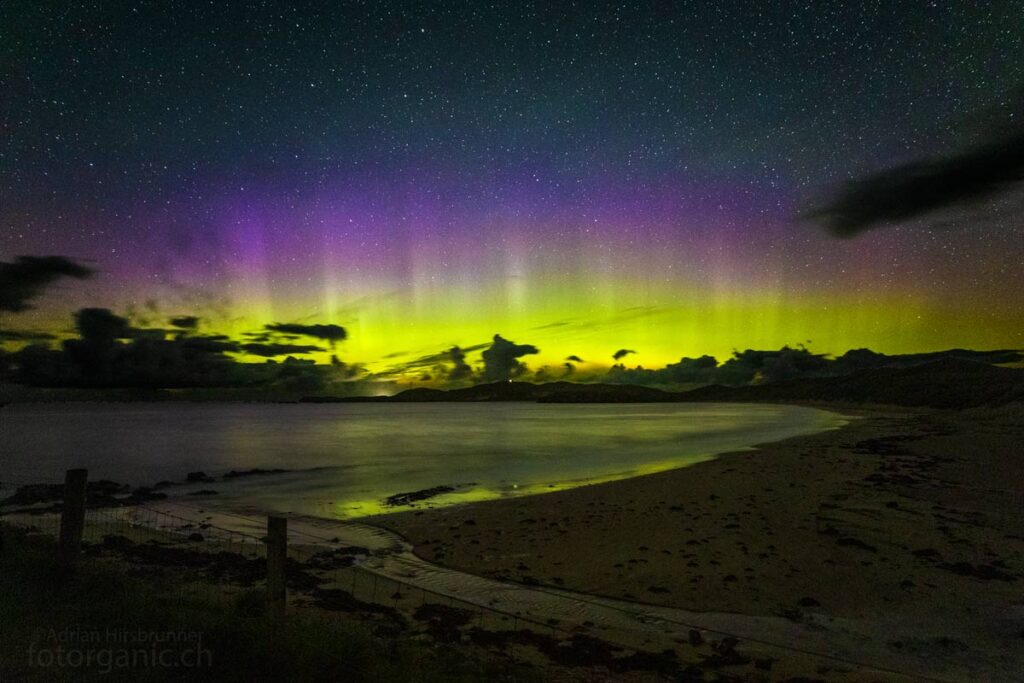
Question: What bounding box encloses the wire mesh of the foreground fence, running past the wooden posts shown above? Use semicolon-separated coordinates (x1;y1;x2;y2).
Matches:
0;485;931;680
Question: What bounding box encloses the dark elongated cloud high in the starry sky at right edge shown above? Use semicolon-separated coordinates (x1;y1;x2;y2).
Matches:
807;129;1024;238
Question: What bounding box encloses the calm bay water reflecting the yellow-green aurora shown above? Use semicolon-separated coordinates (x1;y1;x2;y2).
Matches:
0;403;842;517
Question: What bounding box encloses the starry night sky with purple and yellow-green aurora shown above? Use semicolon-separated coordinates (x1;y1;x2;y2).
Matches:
0;0;1024;372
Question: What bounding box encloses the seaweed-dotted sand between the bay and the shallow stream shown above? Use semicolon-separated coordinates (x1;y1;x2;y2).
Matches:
367;407;1024;676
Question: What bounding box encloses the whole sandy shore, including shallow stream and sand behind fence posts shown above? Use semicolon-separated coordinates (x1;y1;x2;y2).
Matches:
7;405;1024;683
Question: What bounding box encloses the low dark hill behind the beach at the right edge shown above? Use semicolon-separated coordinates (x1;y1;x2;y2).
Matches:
677;358;1024;409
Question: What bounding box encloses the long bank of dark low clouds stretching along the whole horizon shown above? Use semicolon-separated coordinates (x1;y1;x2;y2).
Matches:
0;256;1024;395
